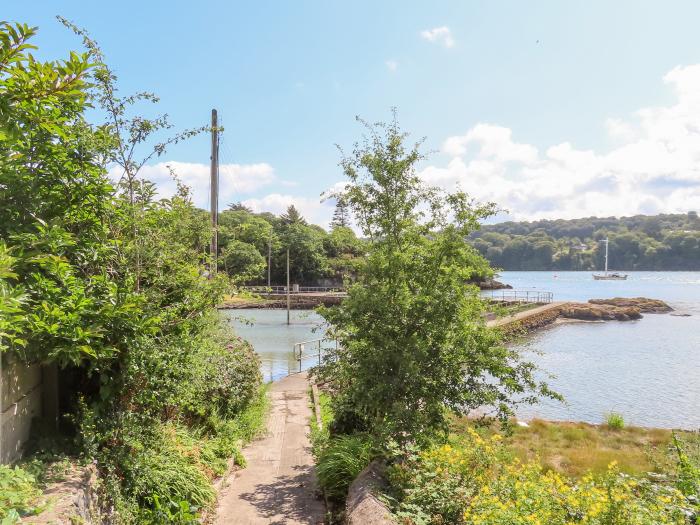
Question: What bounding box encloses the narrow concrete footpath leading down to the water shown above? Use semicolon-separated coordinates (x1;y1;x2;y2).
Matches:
214;374;325;525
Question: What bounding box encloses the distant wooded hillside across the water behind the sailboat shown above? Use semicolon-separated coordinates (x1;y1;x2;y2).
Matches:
470;211;700;271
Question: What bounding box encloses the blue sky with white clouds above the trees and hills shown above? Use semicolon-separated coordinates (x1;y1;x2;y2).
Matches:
8;0;700;226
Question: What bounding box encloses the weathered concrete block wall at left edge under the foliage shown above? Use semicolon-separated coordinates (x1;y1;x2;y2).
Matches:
0;356;42;463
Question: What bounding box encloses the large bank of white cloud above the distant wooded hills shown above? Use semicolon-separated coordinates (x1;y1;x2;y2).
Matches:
421;65;700;219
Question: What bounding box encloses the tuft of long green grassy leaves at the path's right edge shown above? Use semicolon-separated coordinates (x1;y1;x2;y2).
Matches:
316;434;374;499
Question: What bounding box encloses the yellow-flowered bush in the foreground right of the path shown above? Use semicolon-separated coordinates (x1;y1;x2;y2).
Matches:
389;429;689;525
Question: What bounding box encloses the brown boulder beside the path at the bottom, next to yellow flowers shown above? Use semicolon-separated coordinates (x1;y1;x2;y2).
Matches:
345;461;394;525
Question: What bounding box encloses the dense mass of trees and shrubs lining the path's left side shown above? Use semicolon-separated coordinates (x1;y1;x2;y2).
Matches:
0;20;265;524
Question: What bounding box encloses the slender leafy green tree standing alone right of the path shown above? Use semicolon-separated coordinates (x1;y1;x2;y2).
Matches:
317;116;553;443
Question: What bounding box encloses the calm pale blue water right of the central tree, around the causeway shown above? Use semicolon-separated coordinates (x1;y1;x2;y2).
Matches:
501;272;700;429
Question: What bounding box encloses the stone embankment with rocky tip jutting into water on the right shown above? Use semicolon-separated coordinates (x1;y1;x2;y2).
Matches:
489;297;673;333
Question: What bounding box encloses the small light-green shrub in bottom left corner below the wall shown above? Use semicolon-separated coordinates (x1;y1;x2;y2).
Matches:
0;465;41;525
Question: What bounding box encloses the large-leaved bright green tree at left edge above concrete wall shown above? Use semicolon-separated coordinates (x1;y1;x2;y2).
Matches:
0;19;143;366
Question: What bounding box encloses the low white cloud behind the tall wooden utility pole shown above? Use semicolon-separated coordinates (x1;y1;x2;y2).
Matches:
110;161;276;209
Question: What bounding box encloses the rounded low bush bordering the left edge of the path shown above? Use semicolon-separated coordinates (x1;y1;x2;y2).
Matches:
78;318;268;523
